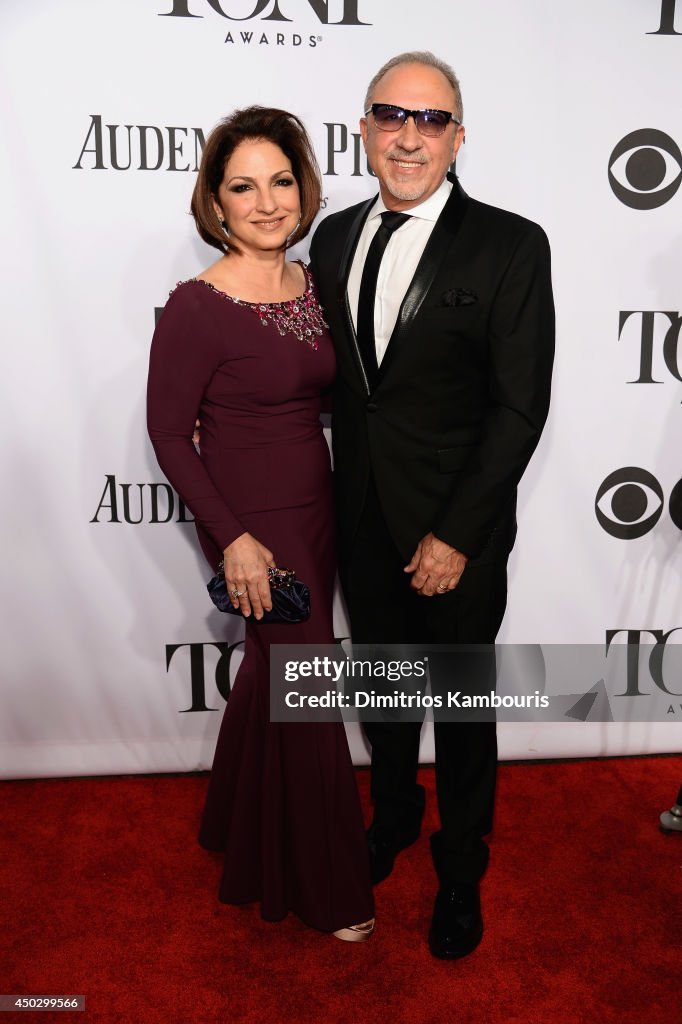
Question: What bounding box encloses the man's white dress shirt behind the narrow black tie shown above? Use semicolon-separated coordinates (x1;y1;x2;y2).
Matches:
348;178;453;365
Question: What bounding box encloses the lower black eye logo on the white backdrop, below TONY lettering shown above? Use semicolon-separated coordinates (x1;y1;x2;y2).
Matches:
594;466;682;541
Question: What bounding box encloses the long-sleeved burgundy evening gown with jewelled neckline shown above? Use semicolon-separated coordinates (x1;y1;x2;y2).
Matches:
147;274;374;932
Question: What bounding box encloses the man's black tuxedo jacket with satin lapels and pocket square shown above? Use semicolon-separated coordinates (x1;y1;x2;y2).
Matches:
310;175;554;562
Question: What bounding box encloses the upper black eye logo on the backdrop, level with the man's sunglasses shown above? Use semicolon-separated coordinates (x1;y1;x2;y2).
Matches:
608;128;682;210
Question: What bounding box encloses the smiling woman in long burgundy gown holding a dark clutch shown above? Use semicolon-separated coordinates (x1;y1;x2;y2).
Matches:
147;108;374;941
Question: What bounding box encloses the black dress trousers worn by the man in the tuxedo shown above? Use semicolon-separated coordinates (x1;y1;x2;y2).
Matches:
341;482;507;886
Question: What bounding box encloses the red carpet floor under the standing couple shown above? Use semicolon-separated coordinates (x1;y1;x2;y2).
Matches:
0;757;682;1024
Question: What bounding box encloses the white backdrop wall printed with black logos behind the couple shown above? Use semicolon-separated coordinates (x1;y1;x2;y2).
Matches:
0;0;682;777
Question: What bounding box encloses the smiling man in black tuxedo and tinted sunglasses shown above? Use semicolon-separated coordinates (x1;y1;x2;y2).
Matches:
310;52;554;959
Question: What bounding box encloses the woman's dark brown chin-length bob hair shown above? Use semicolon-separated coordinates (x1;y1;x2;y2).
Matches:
191;106;322;253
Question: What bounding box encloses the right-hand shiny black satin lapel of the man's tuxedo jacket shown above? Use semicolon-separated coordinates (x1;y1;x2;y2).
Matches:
377;174;467;385
